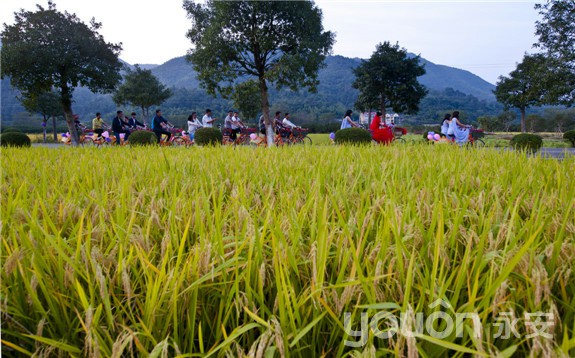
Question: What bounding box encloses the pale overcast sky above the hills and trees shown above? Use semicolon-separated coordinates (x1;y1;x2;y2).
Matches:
0;0;540;84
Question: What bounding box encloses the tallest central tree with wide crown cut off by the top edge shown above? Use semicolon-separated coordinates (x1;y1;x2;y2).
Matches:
184;0;334;146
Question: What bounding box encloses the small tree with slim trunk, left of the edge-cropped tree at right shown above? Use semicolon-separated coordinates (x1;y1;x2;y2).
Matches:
493;54;548;132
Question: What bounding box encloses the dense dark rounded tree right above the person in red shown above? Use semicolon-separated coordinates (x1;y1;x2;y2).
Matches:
352;42;427;117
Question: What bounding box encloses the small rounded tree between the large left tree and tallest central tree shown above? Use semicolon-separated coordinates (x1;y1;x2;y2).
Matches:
112;65;172;124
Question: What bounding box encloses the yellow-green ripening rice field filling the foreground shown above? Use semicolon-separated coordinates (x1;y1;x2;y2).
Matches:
0;145;575;357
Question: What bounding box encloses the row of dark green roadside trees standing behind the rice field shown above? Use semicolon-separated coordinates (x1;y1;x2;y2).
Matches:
1;0;575;142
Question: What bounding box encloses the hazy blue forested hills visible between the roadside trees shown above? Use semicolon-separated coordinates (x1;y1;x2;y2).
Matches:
1;56;502;129
